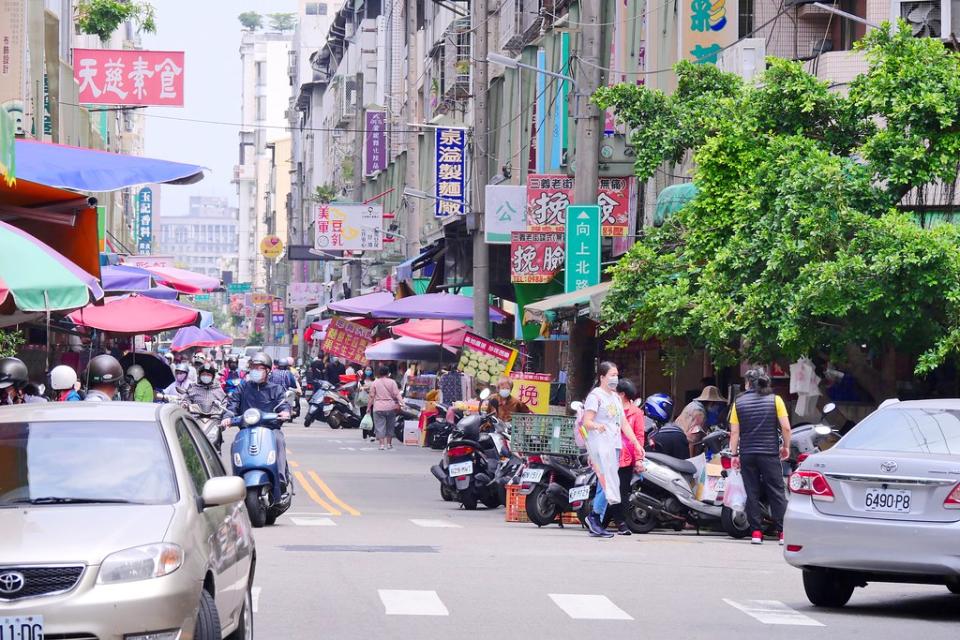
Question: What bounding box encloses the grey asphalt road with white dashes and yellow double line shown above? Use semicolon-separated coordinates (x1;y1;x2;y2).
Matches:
231;422;960;640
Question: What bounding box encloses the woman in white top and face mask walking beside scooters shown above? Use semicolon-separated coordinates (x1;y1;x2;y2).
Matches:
583;362;630;538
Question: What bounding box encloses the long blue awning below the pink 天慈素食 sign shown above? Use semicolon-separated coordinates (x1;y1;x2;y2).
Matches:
16;140;205;191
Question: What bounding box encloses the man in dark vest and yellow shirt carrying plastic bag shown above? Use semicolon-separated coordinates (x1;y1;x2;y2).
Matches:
730;368;790;545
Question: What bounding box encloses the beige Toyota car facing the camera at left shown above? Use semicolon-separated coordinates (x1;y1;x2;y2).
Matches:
0;402;255;640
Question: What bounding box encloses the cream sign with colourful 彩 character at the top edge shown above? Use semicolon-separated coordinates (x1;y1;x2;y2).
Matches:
677;0;740;64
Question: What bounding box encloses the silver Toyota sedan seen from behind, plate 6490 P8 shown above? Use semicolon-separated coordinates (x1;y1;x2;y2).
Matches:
784;399;960;607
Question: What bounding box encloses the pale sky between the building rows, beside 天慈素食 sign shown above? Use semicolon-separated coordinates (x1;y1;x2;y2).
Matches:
143;0;297;215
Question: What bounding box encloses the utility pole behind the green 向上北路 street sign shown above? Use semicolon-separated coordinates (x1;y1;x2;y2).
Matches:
567;0;601;400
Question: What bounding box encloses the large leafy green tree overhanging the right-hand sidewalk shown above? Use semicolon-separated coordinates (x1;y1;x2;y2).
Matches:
594;23;960;399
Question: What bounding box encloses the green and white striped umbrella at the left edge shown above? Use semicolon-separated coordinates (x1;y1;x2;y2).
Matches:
0;222;103;313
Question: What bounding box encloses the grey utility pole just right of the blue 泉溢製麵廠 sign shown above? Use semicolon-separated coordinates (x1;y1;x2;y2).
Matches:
468;0;490;336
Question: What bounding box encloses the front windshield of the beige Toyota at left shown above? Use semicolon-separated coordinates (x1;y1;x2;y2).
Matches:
0;421;177;507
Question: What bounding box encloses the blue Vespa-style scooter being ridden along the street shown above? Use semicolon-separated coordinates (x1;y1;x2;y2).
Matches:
230;409;293;528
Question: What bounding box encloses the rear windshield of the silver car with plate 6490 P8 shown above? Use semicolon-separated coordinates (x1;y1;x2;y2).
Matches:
837;407;960;455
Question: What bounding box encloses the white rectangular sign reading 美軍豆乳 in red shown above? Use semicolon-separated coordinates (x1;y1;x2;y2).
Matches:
314;203;383;251
